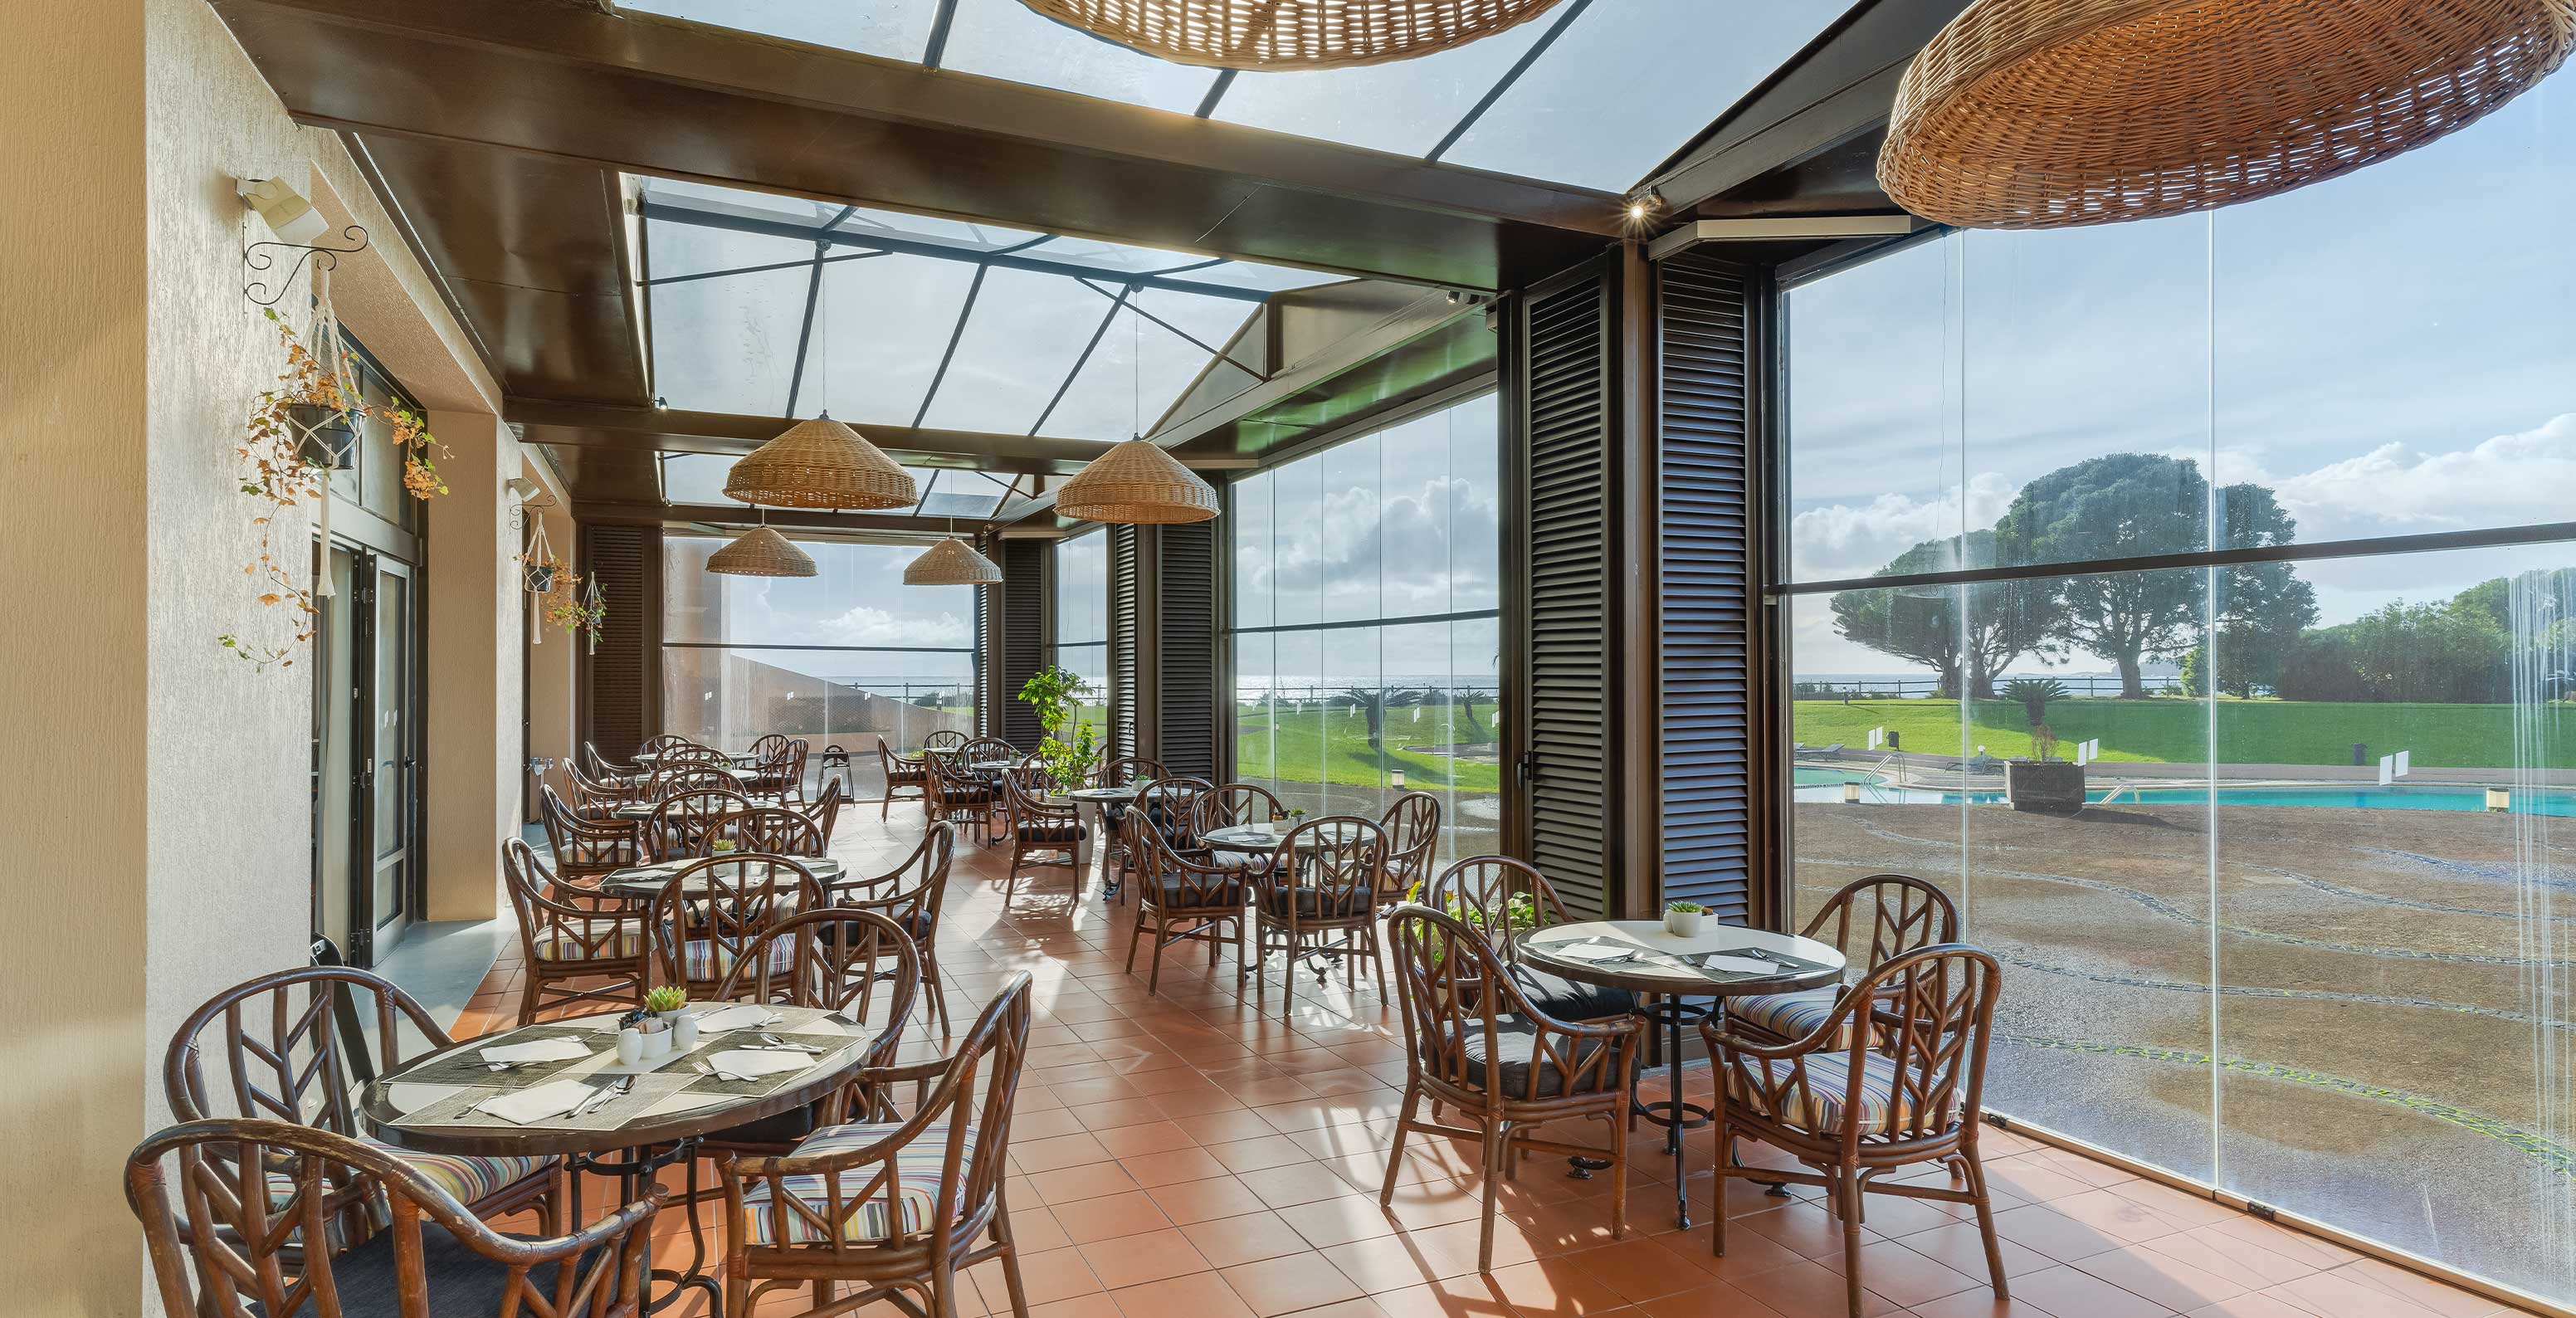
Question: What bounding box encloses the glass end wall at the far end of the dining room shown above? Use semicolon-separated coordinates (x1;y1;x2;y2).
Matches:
662;535;976;798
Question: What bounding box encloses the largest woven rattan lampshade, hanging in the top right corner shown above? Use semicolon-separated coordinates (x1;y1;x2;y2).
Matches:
1878;0;2576;229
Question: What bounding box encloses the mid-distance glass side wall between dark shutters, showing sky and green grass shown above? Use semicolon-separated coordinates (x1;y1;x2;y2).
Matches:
1227;397;1502;860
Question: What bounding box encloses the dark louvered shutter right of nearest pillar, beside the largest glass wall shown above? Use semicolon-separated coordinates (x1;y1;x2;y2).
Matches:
1656;255;1754;921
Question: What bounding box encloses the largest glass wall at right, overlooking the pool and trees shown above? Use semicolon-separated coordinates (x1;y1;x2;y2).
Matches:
1773;66;2576;1302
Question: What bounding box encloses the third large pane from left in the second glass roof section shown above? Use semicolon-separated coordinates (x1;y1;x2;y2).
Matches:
922;268;1108;435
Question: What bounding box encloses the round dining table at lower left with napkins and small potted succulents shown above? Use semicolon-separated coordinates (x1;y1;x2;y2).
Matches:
358;1002;878;1316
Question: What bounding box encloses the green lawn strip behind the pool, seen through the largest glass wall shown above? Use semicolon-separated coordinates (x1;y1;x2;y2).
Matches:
1795;698;2576;769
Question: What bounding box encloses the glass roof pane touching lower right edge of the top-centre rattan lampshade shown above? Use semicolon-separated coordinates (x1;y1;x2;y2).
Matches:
1221;18;1555;154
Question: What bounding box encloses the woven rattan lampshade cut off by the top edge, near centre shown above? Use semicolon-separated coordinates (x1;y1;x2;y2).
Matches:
1020;0;1559;70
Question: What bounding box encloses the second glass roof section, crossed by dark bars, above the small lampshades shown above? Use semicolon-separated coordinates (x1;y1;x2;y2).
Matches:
642;180;1342;445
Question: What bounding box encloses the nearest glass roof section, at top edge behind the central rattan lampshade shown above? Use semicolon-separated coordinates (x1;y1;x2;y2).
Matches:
618;0;1850;193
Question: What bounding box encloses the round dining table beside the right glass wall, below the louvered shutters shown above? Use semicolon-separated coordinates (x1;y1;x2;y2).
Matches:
1520;919;1844;1231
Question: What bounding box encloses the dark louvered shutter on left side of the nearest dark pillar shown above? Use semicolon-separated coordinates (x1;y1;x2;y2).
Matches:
1517;273;1612;919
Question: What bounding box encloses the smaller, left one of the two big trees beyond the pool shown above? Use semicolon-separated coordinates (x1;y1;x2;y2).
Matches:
1832;530;2053;700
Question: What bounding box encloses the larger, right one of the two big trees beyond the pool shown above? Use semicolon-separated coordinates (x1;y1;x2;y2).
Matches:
1993;453;2315;700
